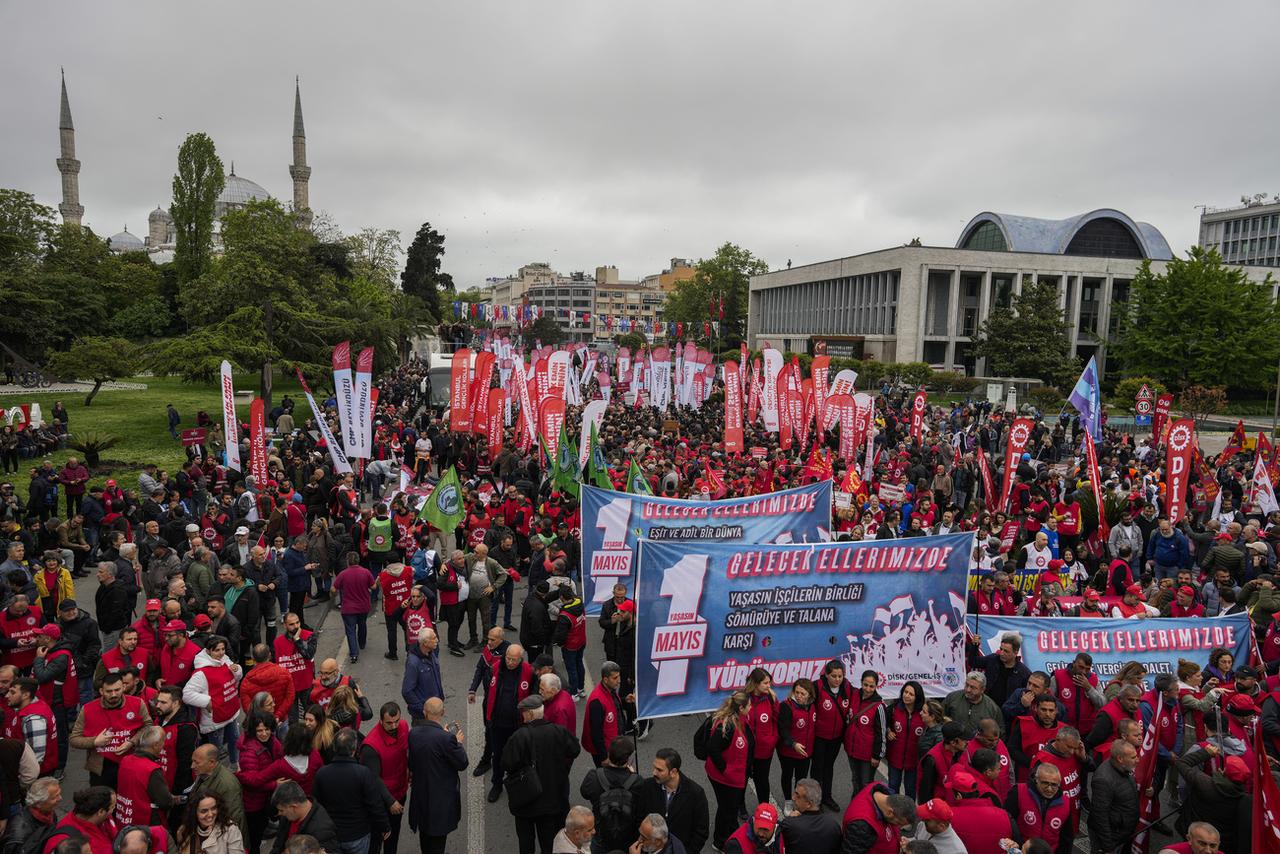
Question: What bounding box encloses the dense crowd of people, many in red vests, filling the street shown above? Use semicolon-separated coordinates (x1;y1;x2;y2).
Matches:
0;348;1259;854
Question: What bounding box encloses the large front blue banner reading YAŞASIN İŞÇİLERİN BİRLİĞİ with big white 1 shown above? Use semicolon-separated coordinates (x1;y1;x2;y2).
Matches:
636;533;974;717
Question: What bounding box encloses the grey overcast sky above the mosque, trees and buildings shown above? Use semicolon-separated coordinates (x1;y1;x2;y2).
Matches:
0;0;1280;287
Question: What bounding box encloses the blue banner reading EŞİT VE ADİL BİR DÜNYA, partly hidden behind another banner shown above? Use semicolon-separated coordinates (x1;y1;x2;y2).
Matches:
581;480;831;615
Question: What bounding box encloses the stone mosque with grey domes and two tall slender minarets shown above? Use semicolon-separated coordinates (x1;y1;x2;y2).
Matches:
56;74;311;264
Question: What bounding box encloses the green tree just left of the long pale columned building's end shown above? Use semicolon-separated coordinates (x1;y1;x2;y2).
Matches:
662;243;769;347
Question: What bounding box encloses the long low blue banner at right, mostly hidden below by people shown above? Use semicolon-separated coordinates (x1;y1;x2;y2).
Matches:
969;613;1253;682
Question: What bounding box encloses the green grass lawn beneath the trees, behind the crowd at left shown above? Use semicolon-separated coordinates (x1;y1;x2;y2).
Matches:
12;374;304;495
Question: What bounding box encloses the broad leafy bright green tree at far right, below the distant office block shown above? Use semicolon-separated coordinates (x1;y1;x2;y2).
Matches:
1115;247;1280;389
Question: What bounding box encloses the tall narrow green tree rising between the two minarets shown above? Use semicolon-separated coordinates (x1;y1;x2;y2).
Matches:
169;133;227;283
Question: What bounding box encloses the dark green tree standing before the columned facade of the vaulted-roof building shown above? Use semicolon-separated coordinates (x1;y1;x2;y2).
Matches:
974;282;1080;388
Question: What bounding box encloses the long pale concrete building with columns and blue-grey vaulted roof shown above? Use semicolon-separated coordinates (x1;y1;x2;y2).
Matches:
748;209;1280;375
